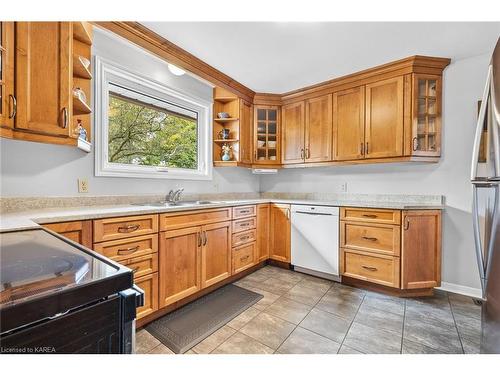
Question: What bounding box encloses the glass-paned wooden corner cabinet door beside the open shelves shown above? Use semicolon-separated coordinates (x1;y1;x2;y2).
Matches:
254;105;280;164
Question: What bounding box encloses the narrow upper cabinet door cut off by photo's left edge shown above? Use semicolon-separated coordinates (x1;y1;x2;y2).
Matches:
0;22;15;128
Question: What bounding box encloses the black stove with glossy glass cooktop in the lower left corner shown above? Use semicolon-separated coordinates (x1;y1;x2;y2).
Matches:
0;229;142;353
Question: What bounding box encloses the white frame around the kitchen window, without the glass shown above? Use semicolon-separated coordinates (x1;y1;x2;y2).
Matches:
94;56;212;180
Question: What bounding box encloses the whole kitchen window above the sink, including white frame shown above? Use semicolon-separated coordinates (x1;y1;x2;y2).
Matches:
94;57;212;180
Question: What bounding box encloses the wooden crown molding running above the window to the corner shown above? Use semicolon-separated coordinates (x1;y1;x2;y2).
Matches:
94;22;255;102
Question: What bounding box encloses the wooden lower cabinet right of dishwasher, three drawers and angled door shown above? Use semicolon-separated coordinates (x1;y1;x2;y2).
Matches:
340;208;441;295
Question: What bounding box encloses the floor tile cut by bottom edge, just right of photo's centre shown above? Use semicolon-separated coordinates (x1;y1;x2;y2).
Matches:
277;327;340;354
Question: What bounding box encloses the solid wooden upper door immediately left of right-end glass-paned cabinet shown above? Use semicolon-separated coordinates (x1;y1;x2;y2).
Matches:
365;76;404;158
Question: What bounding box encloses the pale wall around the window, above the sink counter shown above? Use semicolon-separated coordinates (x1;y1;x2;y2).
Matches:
0;30;259;197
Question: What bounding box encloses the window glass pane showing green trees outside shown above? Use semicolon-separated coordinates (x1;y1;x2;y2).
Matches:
108;85;198;169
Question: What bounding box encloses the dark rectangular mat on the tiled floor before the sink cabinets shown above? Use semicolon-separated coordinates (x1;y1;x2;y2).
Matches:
145;284;264;353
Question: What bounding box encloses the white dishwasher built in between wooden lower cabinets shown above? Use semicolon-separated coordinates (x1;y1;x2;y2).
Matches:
291;205;340;281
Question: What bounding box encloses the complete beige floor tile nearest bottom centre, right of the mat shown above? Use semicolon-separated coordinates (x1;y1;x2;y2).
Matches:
240;312;296;349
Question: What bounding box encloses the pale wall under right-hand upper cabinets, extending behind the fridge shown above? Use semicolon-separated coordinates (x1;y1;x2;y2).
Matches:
261;54;490;294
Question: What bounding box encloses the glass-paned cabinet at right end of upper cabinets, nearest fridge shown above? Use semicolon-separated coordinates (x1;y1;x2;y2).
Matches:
412;74;441;156
